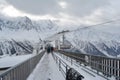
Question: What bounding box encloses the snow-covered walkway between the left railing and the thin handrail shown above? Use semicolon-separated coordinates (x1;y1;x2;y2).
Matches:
27;53;65;80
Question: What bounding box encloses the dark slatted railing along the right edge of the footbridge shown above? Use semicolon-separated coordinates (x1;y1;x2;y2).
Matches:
58;51;120;80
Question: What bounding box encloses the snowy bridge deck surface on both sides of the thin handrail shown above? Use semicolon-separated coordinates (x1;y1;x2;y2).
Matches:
27;53;113;80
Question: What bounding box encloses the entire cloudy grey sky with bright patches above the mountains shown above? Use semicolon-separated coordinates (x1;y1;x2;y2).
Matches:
0;0;120;25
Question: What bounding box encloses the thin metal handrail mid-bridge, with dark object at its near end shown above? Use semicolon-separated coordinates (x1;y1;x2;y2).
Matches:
53;54;84;80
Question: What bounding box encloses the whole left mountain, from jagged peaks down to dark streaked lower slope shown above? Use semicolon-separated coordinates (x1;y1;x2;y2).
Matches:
0;17;58;55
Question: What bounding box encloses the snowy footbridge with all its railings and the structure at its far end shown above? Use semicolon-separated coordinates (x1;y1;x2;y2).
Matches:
0;31;120;80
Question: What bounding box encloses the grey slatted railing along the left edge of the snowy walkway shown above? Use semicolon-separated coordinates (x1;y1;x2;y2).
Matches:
0;51;44;80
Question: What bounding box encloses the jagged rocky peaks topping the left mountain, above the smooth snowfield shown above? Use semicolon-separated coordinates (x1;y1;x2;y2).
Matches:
0;16;58;31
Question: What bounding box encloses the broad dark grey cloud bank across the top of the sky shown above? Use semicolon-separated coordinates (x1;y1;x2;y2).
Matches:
7;0;109;16
